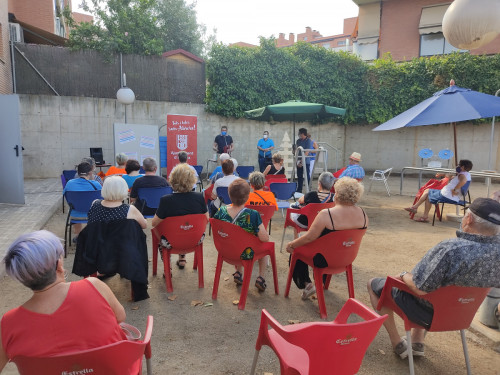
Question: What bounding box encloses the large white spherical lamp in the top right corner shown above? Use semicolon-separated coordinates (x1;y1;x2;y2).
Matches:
443;0;500;50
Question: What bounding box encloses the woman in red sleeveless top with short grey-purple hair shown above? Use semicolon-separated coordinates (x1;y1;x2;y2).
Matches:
0;230;126;372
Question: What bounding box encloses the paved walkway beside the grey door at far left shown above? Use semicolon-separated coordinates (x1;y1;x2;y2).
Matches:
0;178;62;254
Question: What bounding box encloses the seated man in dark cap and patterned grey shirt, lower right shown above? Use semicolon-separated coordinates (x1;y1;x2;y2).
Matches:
368;198;500;358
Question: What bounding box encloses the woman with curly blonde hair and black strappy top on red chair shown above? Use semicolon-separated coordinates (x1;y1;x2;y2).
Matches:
286;177;368;300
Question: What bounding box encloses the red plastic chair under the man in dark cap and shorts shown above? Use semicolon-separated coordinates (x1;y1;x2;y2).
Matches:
377;277;490;375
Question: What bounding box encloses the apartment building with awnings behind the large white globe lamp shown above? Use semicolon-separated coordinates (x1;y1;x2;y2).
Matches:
353;0;500;61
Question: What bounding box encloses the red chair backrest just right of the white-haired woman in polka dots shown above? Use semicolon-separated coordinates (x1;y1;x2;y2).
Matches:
152;214;208;249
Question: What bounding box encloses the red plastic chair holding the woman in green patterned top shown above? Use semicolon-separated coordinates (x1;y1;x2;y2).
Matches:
210;219;279;310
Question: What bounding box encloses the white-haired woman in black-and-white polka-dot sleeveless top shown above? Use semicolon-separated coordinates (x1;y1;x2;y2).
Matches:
88;176;148;229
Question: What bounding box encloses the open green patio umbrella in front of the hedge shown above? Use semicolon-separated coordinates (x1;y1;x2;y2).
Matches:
245;100;345;144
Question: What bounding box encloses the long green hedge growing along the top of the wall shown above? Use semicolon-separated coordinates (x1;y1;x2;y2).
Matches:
206;38;500;124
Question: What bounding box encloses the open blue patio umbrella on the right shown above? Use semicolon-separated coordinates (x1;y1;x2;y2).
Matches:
373;84;500;167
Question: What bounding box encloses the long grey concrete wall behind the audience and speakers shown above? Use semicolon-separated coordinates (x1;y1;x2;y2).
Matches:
20;95;500;178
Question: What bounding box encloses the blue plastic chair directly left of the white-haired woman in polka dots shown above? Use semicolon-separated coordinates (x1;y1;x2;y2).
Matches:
64;190;102;258
